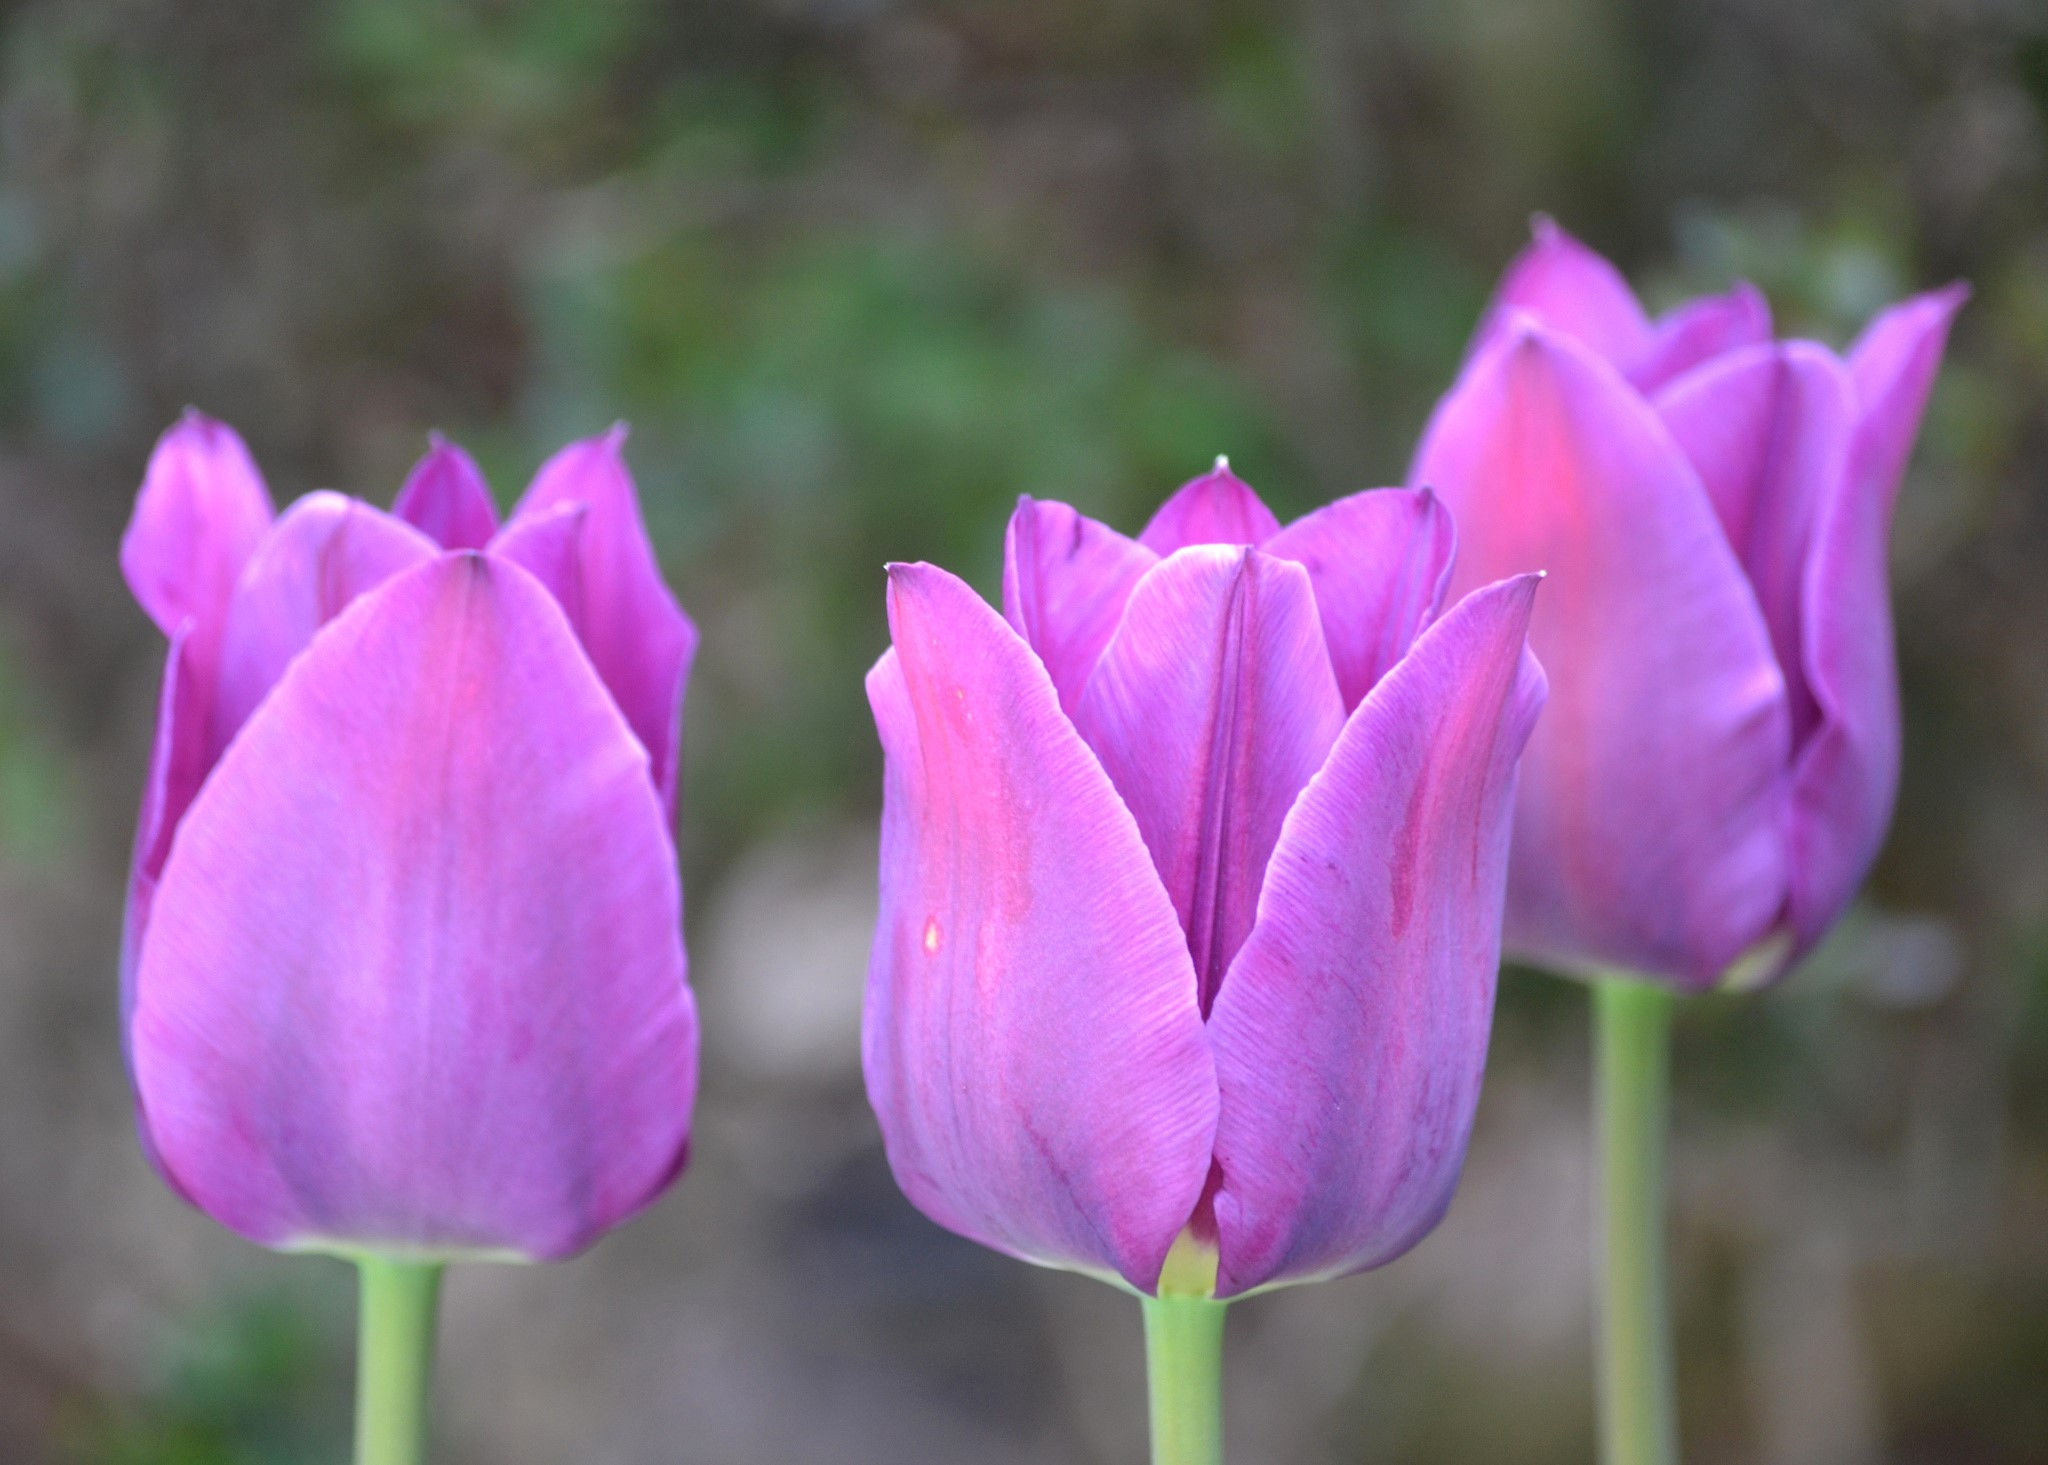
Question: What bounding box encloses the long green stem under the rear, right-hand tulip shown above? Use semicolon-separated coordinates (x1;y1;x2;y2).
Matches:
1593;977;1677;1465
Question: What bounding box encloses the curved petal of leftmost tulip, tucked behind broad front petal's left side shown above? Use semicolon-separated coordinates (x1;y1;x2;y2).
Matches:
207;490;436;762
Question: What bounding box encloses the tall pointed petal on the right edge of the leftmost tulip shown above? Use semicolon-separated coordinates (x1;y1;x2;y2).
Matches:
508;426;696;809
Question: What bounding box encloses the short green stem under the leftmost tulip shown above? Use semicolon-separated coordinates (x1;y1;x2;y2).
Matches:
356;1256;440;1465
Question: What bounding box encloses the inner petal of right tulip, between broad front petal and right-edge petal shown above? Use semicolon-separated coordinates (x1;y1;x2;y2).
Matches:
1657;342;1855;748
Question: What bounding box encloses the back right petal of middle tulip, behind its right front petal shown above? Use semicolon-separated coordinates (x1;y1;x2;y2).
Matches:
1266;488;1458;711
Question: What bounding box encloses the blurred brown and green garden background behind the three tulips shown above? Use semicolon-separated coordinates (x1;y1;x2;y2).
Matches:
0;0;2048;1465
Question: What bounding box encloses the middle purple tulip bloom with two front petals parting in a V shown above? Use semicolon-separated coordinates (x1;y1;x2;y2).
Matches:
862;463;1542;1297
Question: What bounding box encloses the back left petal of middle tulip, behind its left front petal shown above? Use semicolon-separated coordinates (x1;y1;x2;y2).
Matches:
1004;498;1159;713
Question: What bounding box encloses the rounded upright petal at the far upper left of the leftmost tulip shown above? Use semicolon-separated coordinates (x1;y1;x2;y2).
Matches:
121;412;272;643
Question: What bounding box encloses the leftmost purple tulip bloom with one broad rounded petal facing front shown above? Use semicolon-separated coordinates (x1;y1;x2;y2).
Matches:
121;414;696;1258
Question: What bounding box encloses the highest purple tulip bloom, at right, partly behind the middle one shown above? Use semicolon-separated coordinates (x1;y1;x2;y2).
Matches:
1413;219;1964;990
